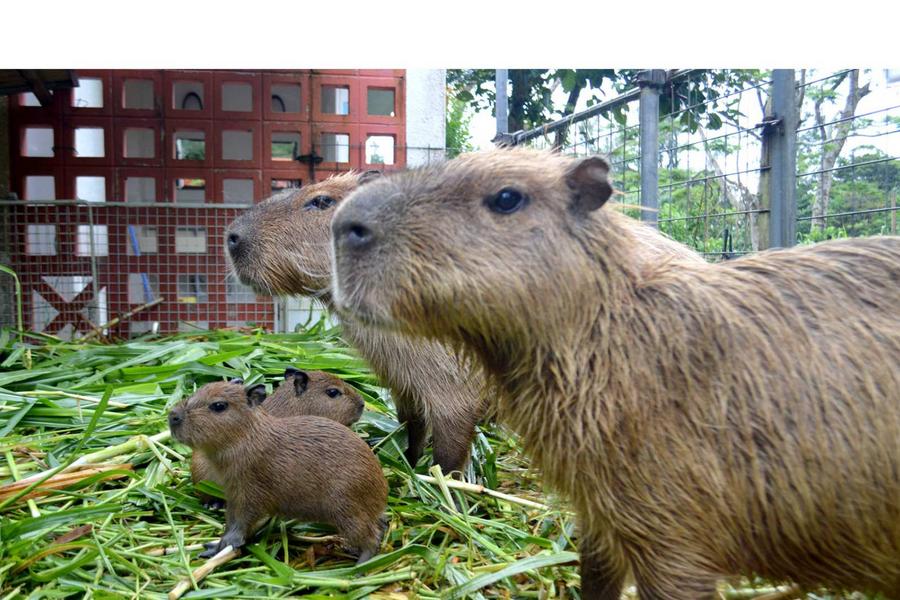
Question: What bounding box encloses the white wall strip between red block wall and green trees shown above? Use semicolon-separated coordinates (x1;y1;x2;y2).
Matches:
406;69;447;167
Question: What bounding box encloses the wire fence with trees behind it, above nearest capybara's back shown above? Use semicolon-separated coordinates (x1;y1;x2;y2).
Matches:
507;70;900;259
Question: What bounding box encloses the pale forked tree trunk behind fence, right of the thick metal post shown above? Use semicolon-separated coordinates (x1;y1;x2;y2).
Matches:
811;69;869;232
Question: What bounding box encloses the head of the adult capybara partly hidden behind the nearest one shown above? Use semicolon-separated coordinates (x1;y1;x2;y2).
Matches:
225;171;380;295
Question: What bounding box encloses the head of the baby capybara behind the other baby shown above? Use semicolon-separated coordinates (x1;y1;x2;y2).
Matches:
263;367;365;427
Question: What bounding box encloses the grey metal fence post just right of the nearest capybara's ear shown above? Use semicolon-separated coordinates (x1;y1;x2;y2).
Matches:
638;69;666;227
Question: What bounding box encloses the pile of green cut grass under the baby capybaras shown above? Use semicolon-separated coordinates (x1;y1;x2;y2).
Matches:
0;323;578;598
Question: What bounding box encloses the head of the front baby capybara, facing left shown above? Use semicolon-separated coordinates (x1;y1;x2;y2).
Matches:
169;379;266;449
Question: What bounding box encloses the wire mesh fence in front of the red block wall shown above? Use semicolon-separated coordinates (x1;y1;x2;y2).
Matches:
0;146;444;339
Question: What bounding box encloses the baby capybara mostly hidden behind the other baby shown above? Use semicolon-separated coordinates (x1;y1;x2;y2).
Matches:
191;367;365;508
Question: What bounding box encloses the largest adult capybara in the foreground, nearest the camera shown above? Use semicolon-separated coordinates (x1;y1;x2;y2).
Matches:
333;150;900;599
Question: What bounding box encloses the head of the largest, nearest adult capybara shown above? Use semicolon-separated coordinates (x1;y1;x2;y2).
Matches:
332;149;625;338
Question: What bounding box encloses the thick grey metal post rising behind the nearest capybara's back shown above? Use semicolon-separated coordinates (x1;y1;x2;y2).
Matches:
767;69;797;248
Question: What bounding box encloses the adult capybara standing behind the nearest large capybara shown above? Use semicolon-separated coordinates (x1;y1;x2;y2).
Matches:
226;171;702;472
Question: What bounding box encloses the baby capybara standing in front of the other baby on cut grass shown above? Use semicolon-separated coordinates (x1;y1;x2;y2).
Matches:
169;382;387;564
